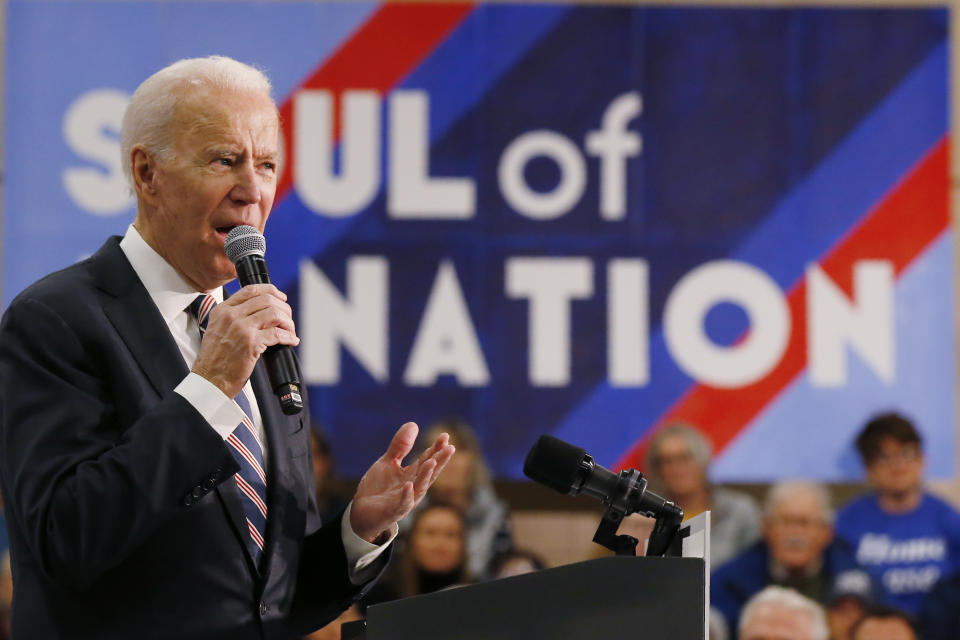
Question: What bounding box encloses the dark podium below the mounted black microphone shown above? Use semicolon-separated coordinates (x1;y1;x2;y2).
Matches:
343;556;707;640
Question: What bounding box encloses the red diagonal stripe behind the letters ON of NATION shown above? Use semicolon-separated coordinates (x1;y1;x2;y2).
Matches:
616;137;950;469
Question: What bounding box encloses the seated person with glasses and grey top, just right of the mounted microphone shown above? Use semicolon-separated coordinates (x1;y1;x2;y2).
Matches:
646;423;760;566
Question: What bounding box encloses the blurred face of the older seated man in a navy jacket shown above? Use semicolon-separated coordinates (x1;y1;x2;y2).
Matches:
764;489;833;571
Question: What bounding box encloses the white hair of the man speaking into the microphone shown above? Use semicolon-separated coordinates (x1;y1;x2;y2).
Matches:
120;56;271;190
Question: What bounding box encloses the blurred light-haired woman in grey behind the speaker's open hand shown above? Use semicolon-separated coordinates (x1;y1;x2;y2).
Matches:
408;419;513;579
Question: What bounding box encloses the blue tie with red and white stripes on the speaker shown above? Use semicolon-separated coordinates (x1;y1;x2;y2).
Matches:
190;294;267;564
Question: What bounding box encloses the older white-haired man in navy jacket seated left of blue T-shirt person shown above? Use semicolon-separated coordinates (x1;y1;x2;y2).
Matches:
710;481;856;629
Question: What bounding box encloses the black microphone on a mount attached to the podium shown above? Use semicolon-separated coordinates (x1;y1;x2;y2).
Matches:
523;435;683;555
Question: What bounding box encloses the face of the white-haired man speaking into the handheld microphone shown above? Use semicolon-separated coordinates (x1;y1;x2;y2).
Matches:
134;90;279;291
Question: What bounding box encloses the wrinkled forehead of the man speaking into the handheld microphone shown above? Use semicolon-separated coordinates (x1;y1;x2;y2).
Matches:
170;87;280;153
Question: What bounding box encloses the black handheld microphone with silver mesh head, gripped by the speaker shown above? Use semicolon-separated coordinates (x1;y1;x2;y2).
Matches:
223;224;303;416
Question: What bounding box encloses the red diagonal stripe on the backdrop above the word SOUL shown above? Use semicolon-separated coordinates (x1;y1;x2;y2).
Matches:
276;3;473;202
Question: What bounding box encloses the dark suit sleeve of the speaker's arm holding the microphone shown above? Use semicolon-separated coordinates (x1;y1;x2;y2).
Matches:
0;299;236;588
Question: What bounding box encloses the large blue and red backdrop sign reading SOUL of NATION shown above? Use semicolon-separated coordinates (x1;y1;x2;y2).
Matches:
3;0;955;480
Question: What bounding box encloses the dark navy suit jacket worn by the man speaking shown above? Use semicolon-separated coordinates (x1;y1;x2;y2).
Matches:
0;238;387;640
